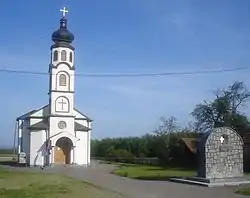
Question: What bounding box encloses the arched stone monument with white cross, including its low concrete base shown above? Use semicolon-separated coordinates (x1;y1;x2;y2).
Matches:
171;127;250;186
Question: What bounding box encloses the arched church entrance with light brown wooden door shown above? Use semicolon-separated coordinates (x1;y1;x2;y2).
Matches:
54;137;73;164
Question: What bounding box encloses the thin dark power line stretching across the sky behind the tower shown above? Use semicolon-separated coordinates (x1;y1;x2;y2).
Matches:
0;67;250;78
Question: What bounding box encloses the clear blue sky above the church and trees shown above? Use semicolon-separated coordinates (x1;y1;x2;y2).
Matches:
0;0;250;146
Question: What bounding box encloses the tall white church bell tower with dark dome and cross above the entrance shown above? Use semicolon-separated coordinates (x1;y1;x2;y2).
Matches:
49;8;75;136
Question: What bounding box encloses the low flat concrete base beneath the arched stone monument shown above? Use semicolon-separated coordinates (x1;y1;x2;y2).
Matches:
170;177;250;187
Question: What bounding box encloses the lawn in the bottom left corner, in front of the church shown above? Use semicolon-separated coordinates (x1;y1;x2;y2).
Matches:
0;169;122;198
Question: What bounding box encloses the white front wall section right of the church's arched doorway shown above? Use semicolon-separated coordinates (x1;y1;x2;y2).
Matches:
75;131;90;165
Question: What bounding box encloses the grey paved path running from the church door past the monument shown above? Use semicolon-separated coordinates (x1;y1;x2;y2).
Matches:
1;162;246;198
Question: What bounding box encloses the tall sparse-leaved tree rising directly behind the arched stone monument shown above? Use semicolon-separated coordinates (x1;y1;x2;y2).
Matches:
191;82;250;135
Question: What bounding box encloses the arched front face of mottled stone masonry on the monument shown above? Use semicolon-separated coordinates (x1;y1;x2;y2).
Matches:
205;127;243;179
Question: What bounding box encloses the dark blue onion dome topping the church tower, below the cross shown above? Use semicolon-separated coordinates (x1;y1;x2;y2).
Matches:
52;17;74;44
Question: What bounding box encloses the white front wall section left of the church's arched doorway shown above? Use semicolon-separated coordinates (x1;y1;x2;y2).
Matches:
30;130;46;166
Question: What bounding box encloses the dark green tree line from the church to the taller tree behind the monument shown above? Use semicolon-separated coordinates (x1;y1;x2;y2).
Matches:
91;81;250;166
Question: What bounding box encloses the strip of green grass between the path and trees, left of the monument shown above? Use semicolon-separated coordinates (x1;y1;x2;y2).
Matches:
113;165;195;180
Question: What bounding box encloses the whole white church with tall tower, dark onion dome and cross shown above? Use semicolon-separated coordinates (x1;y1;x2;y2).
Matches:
15;8;92;166
